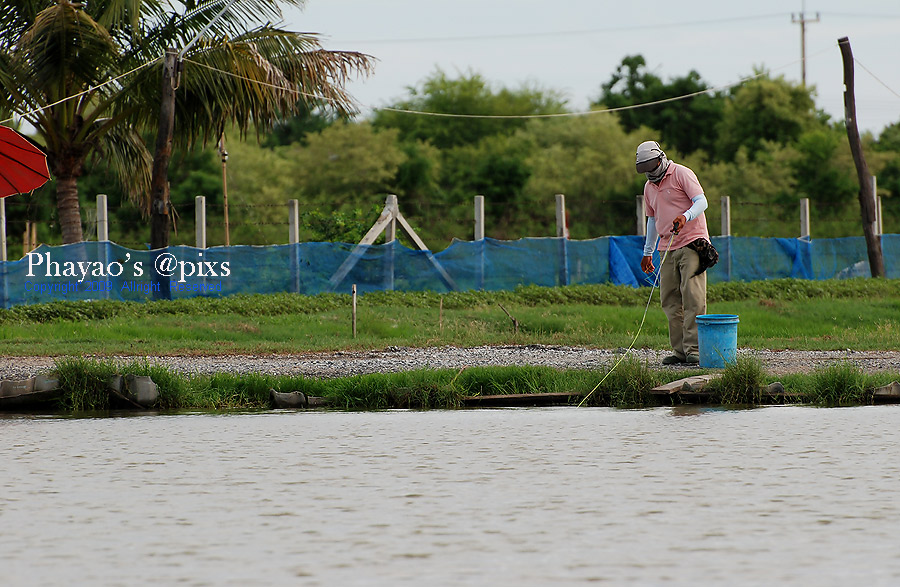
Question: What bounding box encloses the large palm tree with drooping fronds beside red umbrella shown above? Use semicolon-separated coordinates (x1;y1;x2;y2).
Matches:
0;0;374;243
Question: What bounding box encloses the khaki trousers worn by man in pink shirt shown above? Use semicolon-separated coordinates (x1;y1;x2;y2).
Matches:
659;247;706;360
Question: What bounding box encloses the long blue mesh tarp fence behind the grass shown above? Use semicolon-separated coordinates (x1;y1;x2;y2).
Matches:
0;234;900;308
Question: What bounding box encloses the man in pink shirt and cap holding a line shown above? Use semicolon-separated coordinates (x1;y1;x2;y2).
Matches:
635;141;715;365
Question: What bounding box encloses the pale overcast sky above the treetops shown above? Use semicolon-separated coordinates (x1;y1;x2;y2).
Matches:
282;0;900;136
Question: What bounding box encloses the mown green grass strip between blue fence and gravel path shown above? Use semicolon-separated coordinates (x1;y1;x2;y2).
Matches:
0;279;900;356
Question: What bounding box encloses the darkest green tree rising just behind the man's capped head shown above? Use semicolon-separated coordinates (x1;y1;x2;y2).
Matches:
593;55;725;155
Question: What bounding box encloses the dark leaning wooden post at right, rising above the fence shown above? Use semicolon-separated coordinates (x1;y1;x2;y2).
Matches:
838;37;885;277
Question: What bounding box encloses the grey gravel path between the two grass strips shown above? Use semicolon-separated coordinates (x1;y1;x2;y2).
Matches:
0;345;900;379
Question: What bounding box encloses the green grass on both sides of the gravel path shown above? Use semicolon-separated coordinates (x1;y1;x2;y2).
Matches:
7;279;900;411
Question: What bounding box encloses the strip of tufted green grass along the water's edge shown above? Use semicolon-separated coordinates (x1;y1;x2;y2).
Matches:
49;357;900;412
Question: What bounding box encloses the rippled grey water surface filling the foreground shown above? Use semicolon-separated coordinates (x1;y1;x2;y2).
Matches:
0;407;900;586
